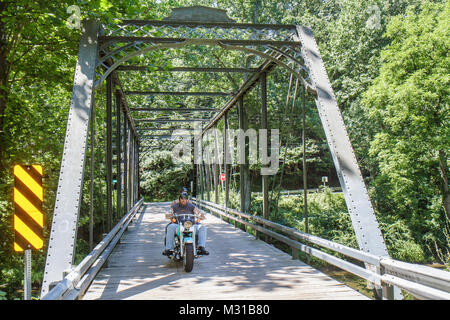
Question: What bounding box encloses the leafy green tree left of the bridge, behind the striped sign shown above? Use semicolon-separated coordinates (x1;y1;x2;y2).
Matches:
0;0;163;298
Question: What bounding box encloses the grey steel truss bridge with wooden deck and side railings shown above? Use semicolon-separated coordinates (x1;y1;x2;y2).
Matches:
41;7;450;299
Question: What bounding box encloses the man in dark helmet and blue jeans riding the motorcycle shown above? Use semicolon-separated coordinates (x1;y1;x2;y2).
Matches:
163;192;209;256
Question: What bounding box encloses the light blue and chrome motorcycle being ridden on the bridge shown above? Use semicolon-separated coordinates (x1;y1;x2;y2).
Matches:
169;213;199;272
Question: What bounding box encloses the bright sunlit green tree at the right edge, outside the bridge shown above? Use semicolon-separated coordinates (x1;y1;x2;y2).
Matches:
364;1;450;260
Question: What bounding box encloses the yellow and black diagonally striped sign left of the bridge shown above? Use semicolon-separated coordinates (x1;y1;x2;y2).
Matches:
14;165;44;252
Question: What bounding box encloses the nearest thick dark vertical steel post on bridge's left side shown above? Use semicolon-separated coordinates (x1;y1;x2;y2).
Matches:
106;76;113;232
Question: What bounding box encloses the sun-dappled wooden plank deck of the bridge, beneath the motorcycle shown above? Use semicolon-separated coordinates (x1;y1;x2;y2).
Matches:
83;202;369;300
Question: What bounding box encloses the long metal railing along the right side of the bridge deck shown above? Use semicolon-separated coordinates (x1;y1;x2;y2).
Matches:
192;198;450;300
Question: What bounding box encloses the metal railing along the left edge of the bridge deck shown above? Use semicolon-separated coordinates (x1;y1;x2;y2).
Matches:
41;199;144;300
